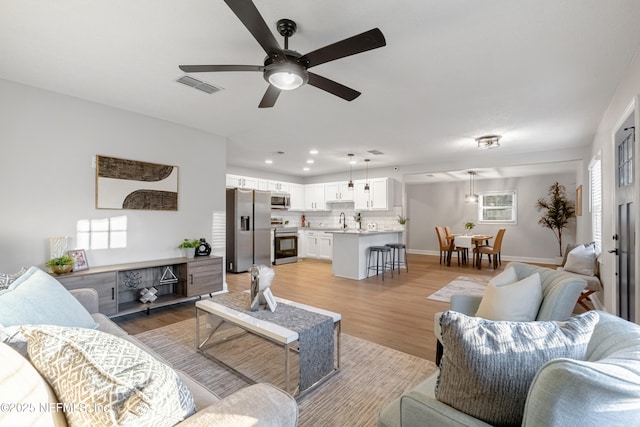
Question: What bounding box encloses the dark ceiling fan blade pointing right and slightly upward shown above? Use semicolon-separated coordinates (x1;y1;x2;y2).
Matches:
299;28;387;68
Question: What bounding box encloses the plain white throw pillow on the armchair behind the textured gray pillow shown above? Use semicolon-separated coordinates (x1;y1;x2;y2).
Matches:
476;269;542;322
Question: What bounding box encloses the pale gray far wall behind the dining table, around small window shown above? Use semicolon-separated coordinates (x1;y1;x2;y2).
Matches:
406;174;576;262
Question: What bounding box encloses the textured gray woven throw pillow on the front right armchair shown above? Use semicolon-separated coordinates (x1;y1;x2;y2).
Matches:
435;311;599;426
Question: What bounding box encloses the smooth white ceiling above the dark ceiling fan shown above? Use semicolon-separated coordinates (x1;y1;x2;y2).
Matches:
0;0;640;176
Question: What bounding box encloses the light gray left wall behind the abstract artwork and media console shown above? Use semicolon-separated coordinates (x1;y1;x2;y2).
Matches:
0;80;226;272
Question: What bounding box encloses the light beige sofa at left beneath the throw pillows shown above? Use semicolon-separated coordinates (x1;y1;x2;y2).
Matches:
0;266;298;427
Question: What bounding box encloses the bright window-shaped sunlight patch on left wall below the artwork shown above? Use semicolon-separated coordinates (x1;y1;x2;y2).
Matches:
76;215;127;249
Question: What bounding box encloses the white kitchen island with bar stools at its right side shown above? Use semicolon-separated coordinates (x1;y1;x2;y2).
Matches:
332;230;403;280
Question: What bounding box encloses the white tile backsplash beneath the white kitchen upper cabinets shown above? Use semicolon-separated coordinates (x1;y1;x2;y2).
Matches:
271;202;402;230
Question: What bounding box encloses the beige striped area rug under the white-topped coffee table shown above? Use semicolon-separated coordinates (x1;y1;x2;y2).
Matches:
136;319;436;427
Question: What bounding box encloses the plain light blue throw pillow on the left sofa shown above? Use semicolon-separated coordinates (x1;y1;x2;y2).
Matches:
0;267;98;328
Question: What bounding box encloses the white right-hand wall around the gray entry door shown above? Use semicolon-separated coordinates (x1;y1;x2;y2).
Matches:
585;46;640;322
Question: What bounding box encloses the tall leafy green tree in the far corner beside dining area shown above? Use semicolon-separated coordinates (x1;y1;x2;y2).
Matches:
536;181;576;258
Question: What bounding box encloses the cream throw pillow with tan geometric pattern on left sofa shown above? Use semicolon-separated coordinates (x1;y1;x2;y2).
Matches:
21;325;195;427
